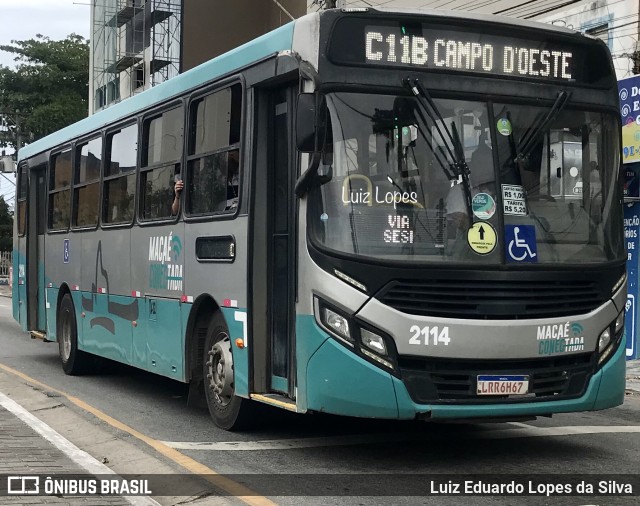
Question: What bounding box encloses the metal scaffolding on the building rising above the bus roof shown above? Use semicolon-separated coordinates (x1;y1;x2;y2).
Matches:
91;0;182;112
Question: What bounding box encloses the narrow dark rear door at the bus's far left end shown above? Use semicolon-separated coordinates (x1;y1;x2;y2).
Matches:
26;165;47;332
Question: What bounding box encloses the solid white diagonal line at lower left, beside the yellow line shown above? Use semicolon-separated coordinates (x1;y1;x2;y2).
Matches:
0;392;160;506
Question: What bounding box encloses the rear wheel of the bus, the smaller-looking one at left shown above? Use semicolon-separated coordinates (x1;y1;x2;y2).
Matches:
56;293;89;376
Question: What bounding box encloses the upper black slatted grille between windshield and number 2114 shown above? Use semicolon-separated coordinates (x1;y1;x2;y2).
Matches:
375;278;608;320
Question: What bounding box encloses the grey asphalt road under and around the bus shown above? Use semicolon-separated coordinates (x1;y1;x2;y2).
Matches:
0;298;640;505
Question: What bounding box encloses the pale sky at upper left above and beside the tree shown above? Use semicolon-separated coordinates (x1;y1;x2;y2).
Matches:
0;0;90;206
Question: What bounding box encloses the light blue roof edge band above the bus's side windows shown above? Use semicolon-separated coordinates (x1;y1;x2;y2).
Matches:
18;21;294;161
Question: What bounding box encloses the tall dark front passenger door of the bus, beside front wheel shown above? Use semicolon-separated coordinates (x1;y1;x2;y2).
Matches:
251;82;297;398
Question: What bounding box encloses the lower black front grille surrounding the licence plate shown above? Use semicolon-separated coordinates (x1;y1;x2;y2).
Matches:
398;353;595;404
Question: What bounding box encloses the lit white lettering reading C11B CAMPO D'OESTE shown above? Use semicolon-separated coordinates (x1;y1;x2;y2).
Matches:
364;27;574;81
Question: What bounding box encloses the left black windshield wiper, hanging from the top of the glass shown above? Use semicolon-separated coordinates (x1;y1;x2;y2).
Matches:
402;78;473;227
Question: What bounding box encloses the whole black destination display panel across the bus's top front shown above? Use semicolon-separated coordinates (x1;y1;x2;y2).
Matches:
326;16;616;88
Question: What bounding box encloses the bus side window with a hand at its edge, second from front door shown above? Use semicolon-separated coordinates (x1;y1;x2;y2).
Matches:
140;107;184;220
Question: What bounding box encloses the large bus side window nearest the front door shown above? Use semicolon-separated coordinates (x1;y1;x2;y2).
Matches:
186;84;242;216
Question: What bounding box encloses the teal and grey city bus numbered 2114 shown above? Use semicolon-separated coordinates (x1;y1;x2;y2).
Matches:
13;8;627;430
